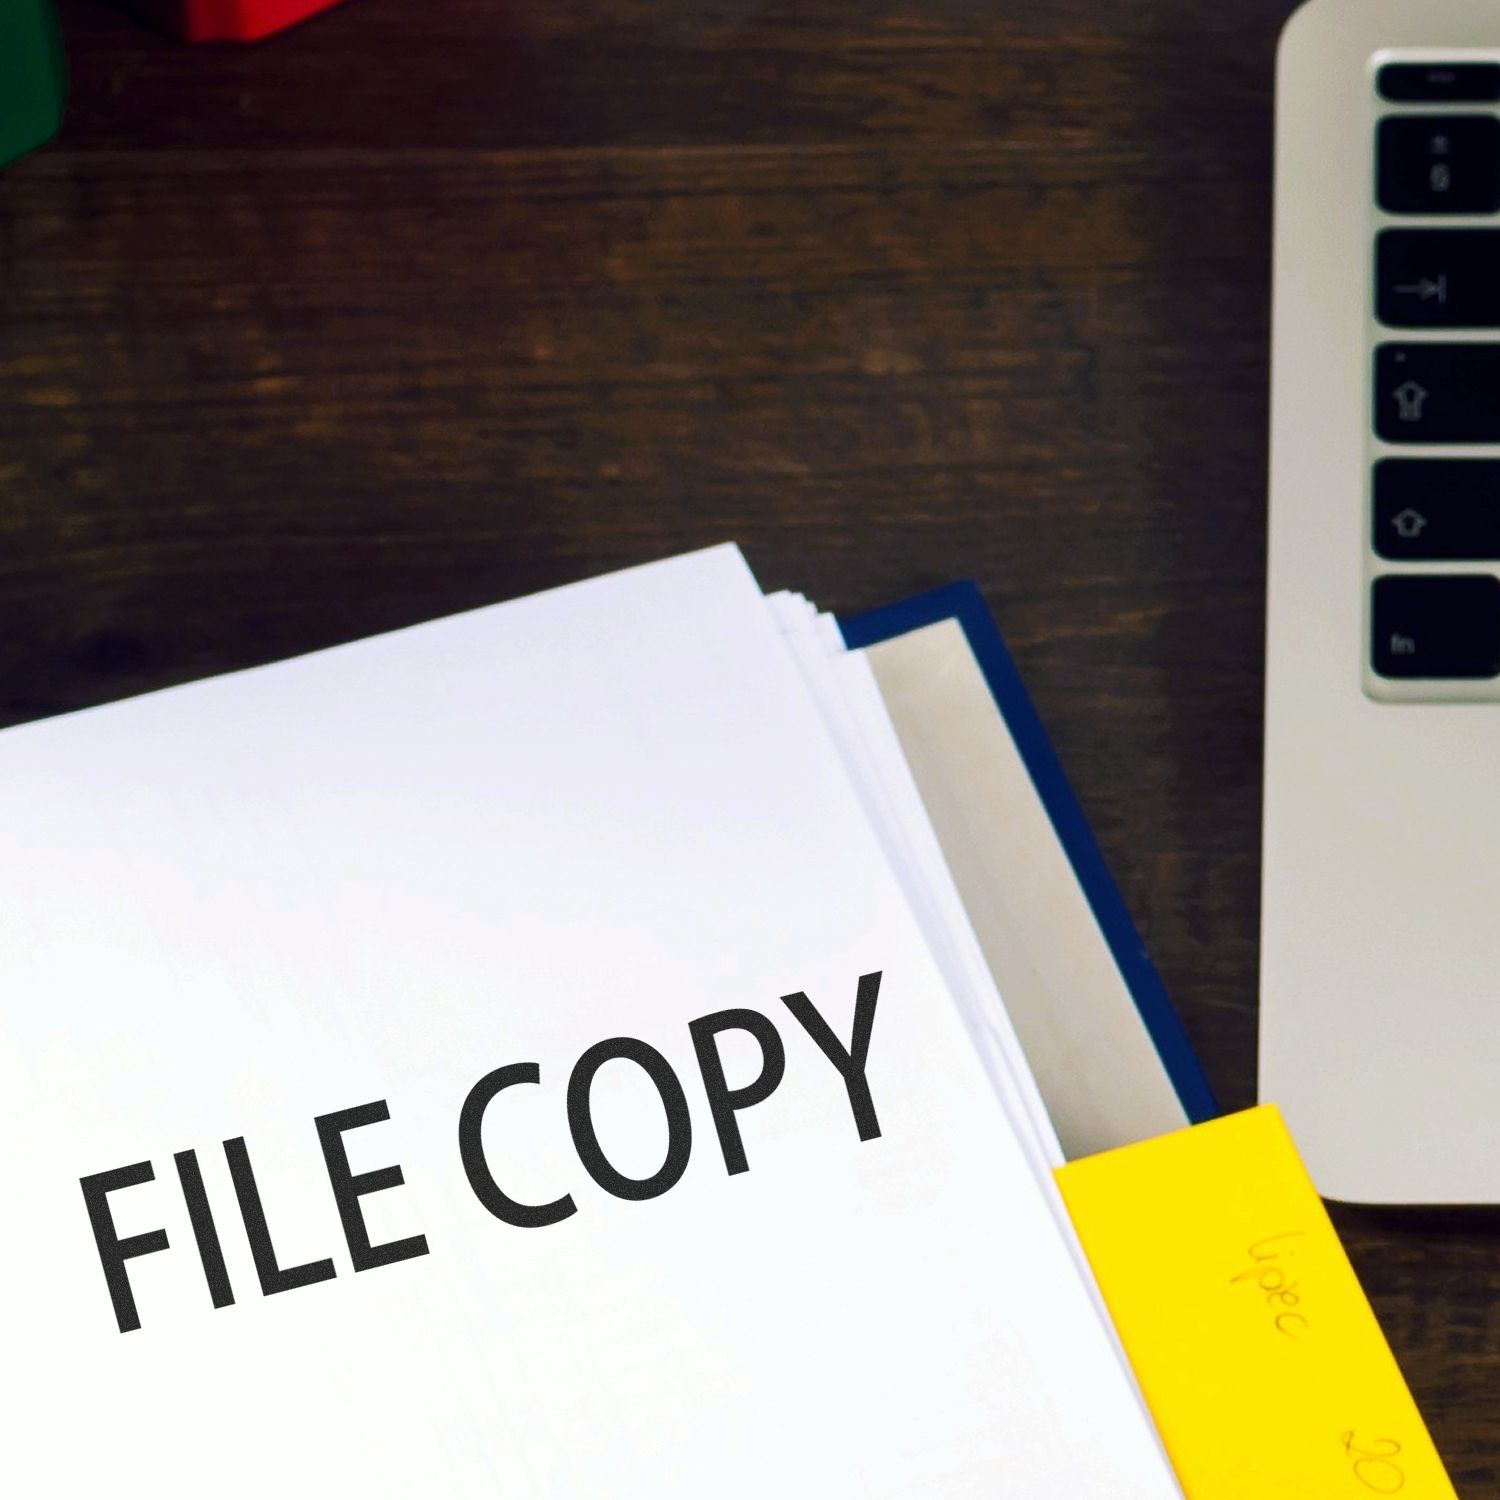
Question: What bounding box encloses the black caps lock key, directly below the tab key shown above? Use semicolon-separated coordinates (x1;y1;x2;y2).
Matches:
1374;344;1500;443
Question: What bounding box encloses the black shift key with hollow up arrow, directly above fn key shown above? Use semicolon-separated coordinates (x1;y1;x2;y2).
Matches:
1371;459;1500;563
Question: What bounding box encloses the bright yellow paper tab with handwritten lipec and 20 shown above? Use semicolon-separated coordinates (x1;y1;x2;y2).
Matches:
1058;1106;1454;1500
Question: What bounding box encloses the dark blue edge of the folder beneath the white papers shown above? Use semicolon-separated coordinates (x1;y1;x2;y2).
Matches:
839;582;1221;1125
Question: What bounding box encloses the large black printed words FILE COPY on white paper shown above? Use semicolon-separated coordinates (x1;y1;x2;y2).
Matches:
80;972;881;1334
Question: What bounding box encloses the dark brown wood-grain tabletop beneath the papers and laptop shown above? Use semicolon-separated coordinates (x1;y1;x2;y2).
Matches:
0;0;1500;1496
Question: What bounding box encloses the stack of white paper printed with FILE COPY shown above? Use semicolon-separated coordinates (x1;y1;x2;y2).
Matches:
0;548;1178;1500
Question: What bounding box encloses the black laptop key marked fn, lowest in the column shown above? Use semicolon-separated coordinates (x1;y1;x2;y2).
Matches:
1371;575;1500;678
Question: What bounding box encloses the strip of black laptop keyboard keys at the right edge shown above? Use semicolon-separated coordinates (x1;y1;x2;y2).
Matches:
1370;60;1500;698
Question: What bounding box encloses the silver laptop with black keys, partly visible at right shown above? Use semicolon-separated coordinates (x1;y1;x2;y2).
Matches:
1260;0;1500;1205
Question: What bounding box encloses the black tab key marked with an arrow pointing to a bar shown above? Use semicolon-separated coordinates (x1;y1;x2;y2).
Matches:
1376;230;1500;329
